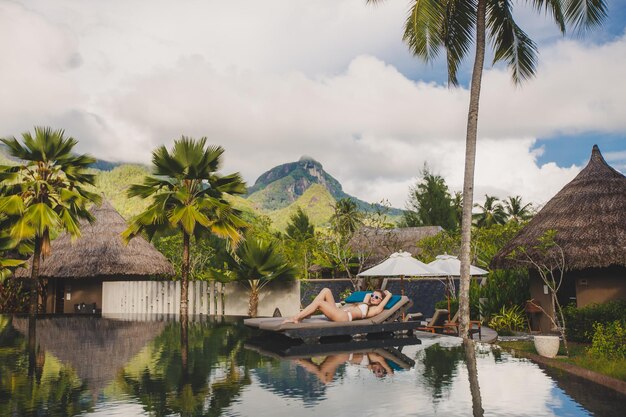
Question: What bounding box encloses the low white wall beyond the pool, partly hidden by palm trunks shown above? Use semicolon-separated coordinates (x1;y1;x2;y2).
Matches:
102;281;300;316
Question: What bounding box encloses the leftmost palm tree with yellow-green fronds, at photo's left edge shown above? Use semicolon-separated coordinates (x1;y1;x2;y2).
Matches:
0;127;100;316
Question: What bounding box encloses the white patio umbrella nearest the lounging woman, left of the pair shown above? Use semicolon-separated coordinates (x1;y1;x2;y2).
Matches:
357;251;442;295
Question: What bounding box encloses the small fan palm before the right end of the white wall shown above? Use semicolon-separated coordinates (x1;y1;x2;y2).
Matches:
222;238;297;317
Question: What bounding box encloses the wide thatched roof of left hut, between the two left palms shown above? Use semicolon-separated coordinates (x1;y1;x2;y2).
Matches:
16;201;175;278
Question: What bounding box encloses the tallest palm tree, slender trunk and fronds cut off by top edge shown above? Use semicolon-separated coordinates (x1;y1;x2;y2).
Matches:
366;0;607;338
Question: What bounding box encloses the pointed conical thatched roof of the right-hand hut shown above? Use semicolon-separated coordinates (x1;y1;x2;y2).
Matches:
491;145;626;270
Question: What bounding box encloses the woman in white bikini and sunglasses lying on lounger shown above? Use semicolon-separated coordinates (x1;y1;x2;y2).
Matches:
285;288;391;323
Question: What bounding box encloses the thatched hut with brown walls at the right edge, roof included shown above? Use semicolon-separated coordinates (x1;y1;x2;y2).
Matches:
491;146;626;332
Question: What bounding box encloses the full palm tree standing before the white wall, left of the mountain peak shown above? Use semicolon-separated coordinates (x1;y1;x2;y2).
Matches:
122;136;247;316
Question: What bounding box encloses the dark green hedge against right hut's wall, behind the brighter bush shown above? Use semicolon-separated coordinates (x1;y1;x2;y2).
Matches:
563;300;626;343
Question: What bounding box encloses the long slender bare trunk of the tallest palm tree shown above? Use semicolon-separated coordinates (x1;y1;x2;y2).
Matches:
459;0;487;339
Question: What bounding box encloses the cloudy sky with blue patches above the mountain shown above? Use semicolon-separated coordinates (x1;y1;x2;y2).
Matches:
0;0;626;207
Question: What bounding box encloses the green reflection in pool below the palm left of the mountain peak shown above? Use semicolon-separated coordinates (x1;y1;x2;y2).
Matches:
118;321;261;416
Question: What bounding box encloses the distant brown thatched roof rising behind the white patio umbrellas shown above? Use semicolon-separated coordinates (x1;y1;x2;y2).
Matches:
349;226;443;265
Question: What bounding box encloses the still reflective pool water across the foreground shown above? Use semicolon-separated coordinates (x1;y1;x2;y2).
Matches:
0;316;626;417
